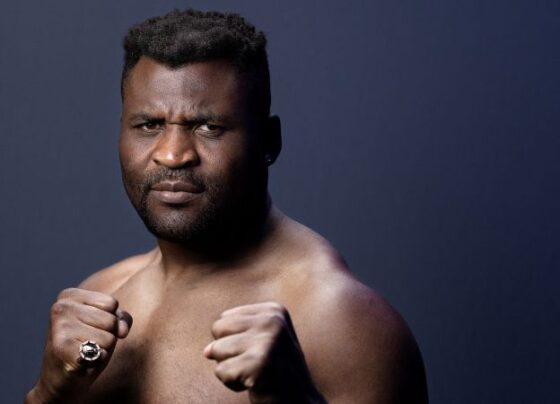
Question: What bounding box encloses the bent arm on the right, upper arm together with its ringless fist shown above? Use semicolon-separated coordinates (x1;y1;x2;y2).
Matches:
204;290;428;404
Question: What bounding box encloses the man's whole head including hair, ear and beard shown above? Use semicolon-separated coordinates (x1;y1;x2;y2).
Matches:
119;10;280;243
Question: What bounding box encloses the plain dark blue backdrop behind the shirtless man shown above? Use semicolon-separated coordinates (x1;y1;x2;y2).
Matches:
0;0;560;404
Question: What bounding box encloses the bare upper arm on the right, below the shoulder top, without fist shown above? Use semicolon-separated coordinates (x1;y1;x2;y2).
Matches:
302;281;428;404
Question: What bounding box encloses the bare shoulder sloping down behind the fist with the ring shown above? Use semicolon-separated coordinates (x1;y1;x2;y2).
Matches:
79;248;158;294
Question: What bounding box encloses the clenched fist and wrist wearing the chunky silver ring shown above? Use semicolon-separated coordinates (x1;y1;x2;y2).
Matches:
26;288;132;403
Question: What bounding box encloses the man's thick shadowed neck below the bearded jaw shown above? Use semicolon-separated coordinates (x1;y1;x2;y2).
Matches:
154;197;278;278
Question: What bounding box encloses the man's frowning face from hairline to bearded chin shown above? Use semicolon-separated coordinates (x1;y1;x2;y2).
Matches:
119;57;266;242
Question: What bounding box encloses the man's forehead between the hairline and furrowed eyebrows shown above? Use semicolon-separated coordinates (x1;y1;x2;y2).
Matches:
123;57;244;117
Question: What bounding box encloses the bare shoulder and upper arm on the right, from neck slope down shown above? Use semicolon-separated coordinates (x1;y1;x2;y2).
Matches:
280;218;428;403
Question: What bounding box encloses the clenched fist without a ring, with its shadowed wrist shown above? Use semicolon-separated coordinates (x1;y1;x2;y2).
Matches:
204;302;326;403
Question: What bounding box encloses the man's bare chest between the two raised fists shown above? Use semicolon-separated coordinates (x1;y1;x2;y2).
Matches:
87;282;274;404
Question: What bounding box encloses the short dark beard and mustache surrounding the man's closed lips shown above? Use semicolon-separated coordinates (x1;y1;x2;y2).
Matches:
121;166;267;245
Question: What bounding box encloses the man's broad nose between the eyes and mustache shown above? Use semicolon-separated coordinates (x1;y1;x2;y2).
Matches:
152;124;200;168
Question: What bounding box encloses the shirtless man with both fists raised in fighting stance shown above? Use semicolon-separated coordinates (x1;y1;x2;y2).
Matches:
26;10;427;403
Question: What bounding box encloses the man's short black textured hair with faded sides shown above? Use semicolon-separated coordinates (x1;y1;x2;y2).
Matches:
121;9;271;116
